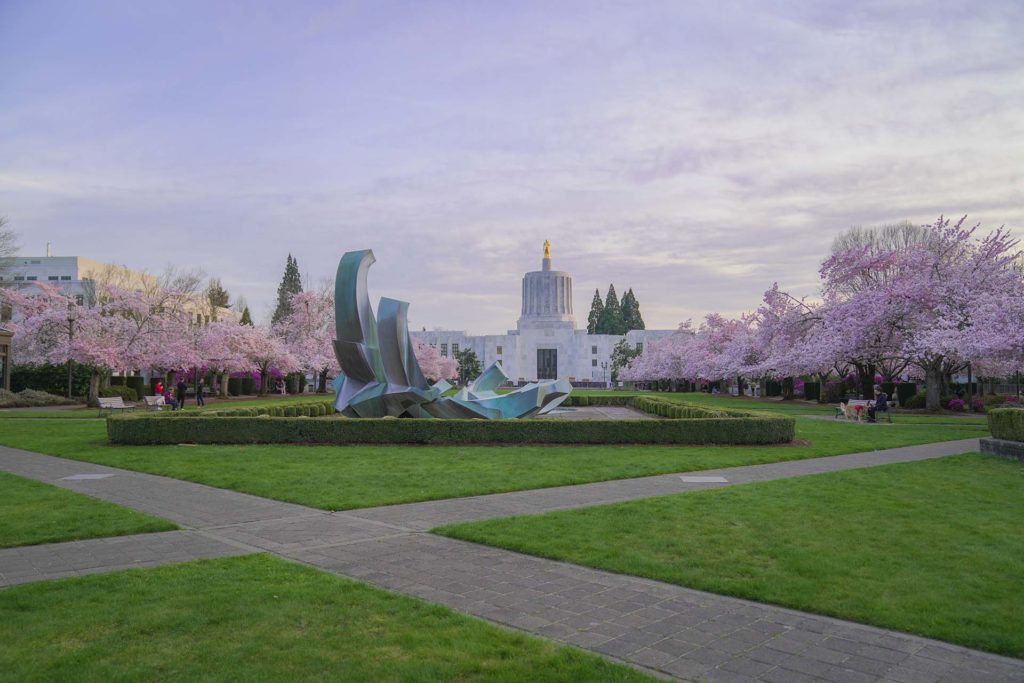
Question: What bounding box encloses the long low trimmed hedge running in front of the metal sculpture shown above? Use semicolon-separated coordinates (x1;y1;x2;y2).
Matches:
106;414;796;444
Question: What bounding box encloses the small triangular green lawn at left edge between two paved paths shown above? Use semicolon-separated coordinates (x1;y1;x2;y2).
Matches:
0;472;177;548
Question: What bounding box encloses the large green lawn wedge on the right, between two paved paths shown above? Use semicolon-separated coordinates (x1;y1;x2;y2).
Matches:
437;455;1024;657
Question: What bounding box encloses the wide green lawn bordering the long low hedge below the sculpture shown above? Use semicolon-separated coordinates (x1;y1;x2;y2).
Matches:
0;418;987;510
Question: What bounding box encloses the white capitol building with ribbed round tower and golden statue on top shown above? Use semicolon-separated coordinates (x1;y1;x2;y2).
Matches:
410;243;673;385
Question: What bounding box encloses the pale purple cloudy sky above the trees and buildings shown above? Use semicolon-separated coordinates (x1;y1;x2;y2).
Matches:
0;0;1024;333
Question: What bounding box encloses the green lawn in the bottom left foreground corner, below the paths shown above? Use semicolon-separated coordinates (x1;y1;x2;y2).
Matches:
0;555;650;681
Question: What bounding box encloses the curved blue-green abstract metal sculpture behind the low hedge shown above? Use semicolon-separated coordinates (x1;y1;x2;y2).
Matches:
334;249;572;419
